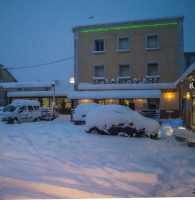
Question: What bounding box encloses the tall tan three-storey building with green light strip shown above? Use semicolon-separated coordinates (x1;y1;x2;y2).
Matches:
68;17;185;118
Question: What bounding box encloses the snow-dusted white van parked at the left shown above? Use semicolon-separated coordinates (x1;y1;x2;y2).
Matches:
3;99;41;123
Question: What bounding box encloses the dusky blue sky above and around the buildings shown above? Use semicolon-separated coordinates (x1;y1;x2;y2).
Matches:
0;0;195;82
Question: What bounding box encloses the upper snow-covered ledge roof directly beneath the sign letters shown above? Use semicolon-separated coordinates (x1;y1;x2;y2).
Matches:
78;83;176;90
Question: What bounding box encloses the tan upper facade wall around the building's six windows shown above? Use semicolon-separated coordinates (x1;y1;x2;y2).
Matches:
78;25;178;83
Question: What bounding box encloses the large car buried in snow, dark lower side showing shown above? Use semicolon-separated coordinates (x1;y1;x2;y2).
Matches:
86;104;160;138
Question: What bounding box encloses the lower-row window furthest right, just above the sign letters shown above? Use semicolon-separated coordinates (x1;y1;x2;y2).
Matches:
146;62;159;78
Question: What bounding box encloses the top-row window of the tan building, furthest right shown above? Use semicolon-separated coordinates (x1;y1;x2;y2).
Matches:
146;34;159;50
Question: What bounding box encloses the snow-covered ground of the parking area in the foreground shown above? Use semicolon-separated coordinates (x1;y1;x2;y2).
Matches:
0;116;195;199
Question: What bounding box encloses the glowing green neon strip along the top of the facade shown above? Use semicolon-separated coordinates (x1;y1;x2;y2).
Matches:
79;22;177;33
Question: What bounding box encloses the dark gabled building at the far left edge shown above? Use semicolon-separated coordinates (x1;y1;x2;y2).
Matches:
0;64;17;107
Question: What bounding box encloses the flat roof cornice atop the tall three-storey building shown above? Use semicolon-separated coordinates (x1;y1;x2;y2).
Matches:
72;16;184;33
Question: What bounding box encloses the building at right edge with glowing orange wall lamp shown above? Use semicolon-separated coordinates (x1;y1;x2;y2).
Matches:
176;62;195;131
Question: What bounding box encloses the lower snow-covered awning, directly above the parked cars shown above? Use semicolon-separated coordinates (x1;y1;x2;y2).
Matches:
68;90;161;99
